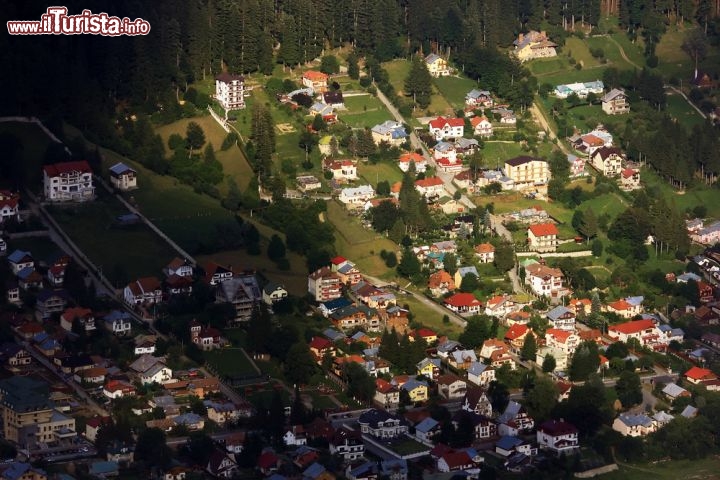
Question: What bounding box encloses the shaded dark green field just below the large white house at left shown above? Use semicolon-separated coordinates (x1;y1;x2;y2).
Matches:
51;188;177;287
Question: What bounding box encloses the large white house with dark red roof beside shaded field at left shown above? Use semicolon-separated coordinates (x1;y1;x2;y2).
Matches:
43;160;95;202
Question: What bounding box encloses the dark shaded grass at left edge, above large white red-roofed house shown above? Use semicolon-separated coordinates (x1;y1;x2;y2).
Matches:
0;122;52;191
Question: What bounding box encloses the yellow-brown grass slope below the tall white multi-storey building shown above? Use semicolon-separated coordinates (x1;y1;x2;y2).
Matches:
156;115;253;192
